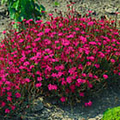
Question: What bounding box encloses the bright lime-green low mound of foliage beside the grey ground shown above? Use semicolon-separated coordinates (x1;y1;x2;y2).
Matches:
102;106;120;120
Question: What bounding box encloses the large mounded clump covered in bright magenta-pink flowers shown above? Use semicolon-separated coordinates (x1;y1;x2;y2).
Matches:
0;4;120;118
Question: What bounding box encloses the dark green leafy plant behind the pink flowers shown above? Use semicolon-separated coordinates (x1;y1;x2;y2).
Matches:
1;0;45;29
